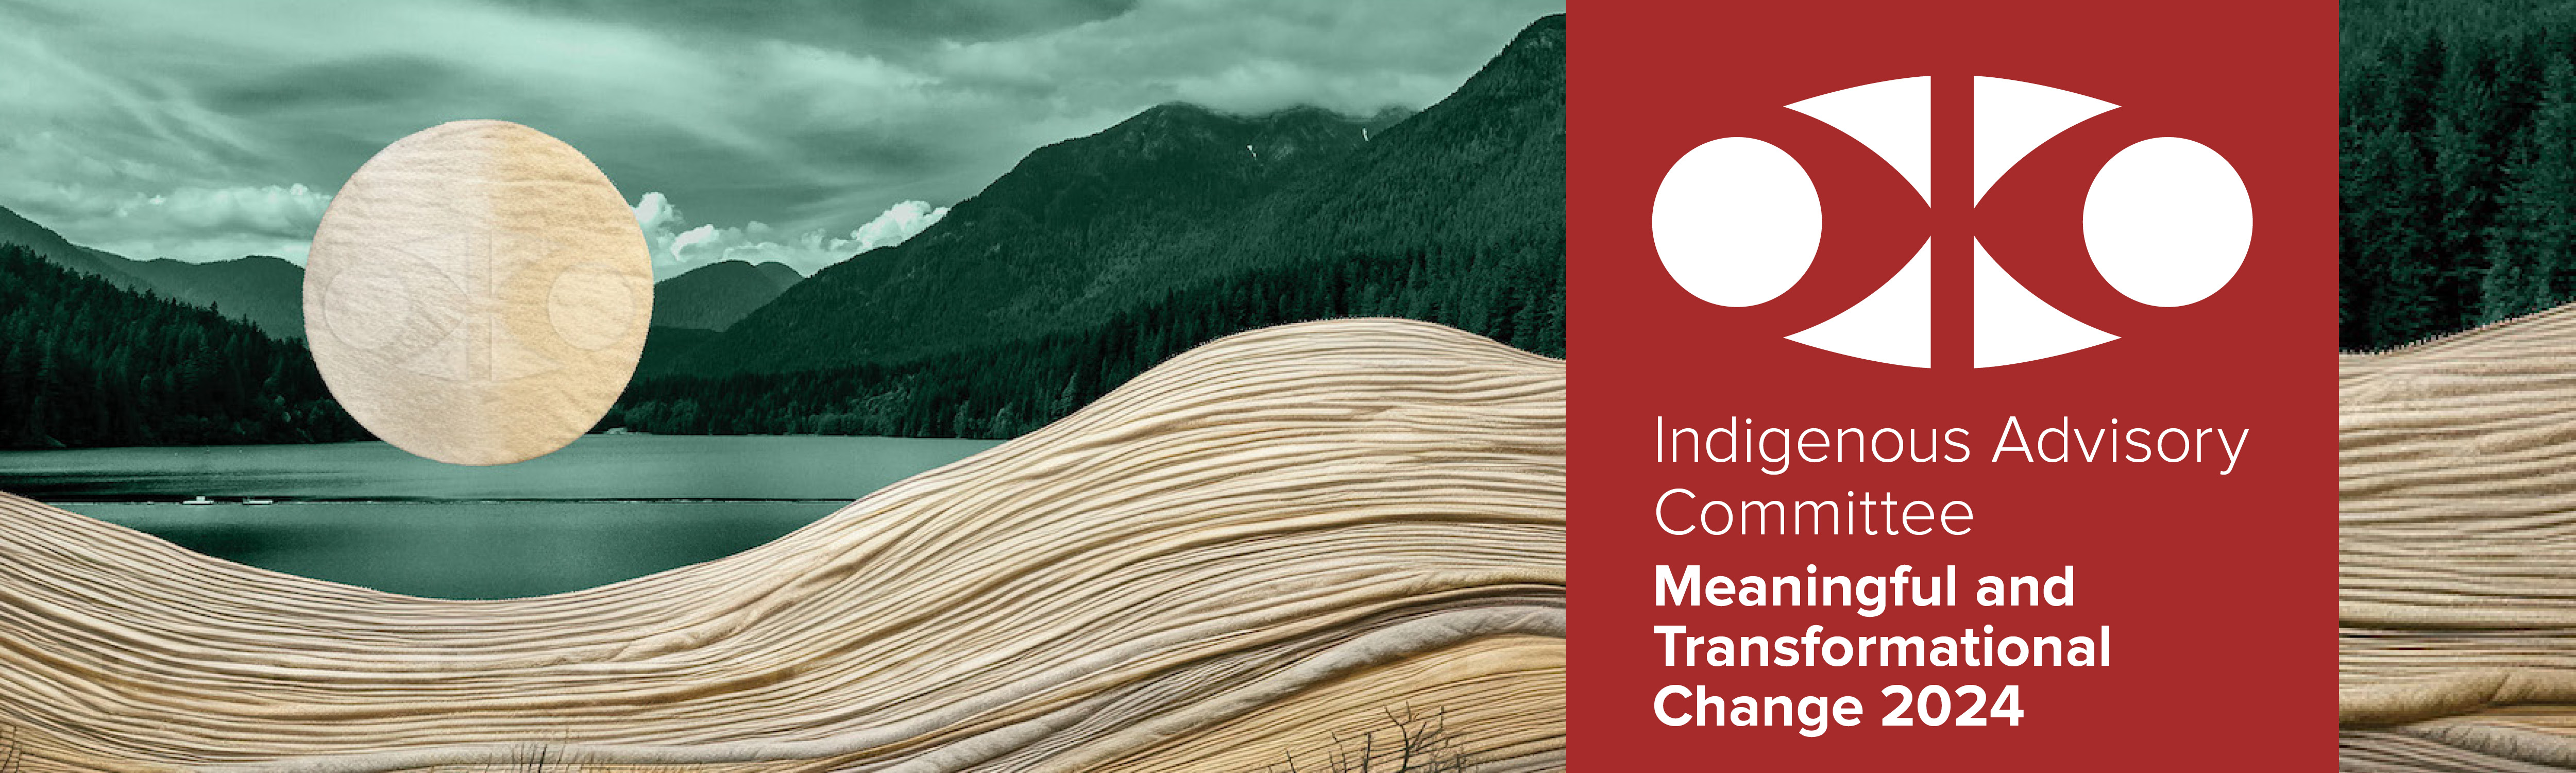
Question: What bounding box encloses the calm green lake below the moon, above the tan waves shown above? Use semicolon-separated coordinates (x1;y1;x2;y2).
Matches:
0;435;997;598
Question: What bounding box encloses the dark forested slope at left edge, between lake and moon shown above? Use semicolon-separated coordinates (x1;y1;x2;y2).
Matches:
0;245;368;448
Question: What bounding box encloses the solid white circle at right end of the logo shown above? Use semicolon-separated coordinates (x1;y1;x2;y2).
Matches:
2084;137;2254;307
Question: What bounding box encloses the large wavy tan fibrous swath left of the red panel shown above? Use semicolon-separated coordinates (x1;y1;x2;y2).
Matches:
0;320;1566;773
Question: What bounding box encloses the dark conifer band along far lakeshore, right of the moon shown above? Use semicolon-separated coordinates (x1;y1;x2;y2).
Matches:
600;234;1566;438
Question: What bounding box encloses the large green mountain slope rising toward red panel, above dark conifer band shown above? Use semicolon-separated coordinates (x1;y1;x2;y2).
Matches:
654;15;1566;374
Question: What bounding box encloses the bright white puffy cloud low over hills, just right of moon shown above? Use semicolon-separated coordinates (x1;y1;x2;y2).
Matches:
634;191;948;281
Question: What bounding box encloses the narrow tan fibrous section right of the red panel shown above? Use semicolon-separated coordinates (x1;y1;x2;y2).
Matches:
2339;307;2576;770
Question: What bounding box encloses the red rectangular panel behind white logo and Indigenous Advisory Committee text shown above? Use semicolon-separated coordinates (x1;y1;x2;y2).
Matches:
1566;3;2336;770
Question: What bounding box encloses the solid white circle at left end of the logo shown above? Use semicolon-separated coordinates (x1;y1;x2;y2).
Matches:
1654;137;1824;307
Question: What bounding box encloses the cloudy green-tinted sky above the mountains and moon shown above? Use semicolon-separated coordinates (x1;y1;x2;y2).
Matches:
0;0;1564;276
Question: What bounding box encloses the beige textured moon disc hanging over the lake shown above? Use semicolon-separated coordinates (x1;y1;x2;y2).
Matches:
304;121;652;464
